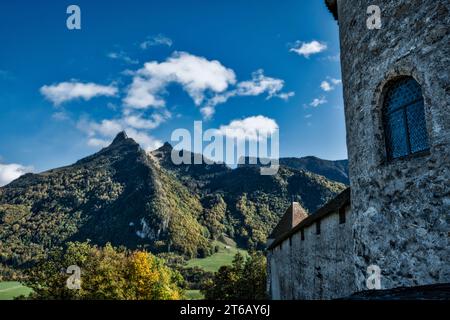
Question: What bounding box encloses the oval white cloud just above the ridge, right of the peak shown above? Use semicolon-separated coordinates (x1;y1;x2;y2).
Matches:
217;115;278;141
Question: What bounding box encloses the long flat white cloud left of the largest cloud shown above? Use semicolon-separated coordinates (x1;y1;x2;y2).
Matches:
40;81;118;106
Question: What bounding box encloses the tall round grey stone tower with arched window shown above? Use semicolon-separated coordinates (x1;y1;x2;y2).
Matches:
326;0;450;290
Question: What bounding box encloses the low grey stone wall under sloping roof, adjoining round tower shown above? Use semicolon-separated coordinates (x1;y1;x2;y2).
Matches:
267;207;356;300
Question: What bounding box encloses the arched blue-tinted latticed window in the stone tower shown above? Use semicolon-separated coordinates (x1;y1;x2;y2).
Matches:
383;77;430;160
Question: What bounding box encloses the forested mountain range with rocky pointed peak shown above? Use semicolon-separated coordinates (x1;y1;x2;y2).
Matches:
0;133;348;267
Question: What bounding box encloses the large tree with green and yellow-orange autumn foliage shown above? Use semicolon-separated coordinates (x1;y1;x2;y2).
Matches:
22;242;184;300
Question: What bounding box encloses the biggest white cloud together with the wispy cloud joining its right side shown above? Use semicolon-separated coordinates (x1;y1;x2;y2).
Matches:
123;52;294;119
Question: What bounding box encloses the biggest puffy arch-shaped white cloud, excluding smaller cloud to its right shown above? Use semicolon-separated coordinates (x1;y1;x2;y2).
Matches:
124;52;236;109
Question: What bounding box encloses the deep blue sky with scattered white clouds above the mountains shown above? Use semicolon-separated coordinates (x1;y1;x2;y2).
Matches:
0;0;347;183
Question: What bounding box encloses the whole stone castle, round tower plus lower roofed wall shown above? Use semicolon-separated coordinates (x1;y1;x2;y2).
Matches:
267;0;450;299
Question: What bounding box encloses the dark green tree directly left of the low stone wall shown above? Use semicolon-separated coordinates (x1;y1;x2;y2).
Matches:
202;252;266;300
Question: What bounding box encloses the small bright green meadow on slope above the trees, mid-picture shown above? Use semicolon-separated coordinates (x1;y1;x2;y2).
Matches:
187;242;247;272
